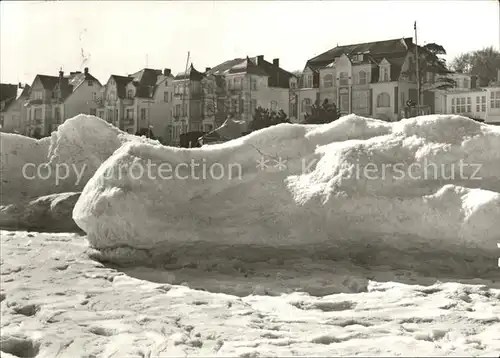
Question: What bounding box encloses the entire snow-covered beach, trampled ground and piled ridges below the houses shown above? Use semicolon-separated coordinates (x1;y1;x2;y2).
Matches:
0;115;500;358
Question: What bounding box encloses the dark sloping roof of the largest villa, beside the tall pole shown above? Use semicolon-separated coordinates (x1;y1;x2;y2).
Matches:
306;37;414;70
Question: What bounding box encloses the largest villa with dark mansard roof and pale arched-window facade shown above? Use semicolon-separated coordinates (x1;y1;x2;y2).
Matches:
298;38;446;121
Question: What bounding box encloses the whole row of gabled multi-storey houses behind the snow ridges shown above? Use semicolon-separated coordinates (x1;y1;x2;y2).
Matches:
1;38;500;145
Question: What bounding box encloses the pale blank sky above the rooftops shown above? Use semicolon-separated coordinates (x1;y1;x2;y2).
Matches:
0;0;500;84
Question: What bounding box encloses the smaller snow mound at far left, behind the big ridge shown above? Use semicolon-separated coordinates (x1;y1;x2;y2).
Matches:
0;114;146;204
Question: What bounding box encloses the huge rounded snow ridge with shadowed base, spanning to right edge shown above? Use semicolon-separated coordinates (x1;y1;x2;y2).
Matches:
73;115;500;265
